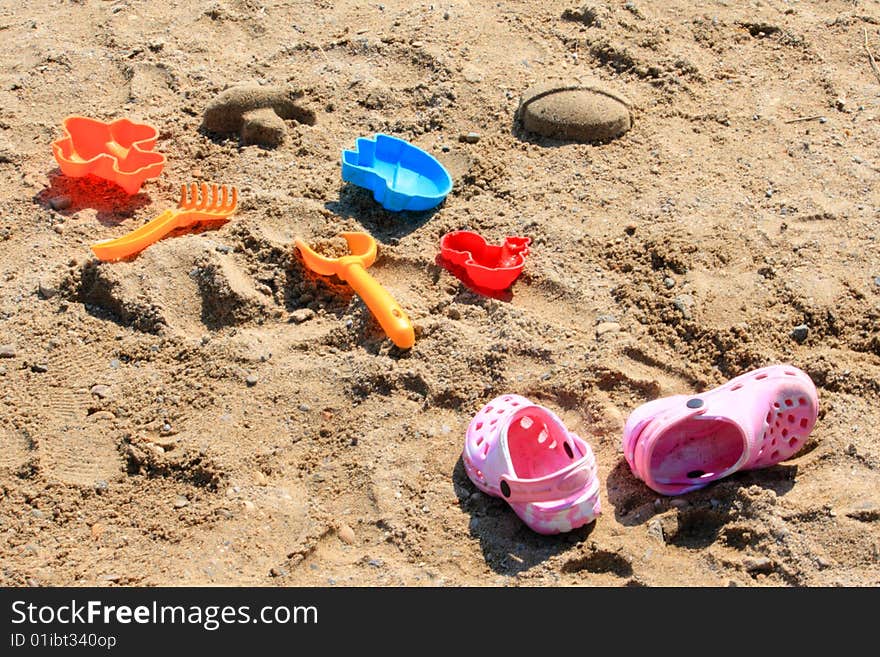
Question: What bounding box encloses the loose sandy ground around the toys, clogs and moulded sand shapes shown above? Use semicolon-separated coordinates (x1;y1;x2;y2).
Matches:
0;0;880;586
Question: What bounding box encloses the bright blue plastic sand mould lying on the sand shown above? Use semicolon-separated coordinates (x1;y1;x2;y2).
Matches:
342;134;452;212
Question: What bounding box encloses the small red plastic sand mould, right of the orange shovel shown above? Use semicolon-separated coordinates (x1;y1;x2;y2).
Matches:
440;230;532;291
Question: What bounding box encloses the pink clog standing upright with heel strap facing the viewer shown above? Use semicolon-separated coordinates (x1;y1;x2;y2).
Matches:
462;395;601;534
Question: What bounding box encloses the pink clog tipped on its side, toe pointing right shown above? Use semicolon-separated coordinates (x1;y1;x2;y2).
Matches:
623;365;819;495
